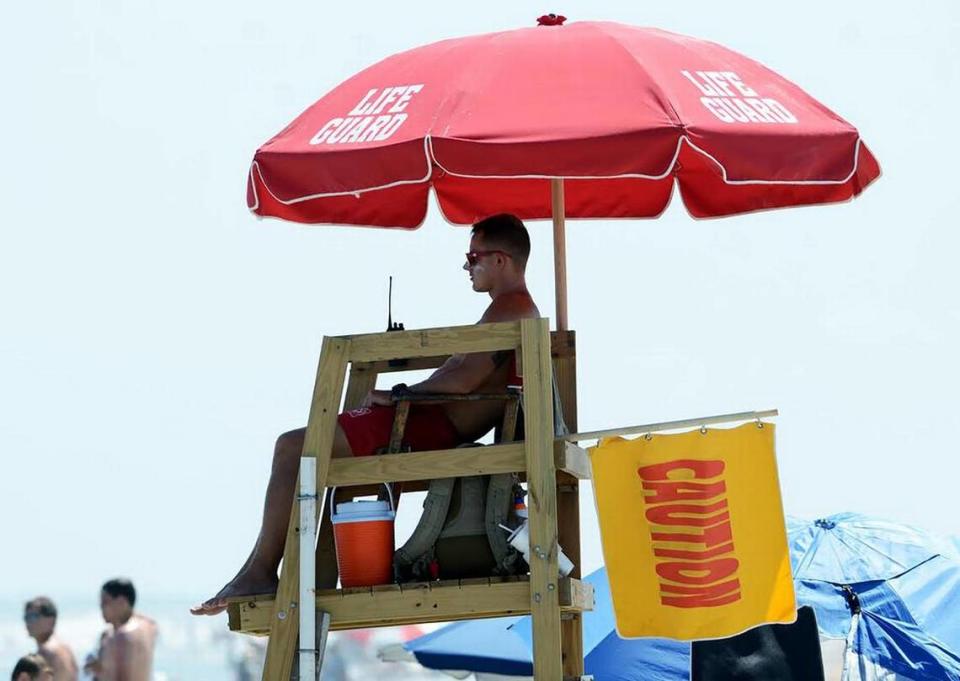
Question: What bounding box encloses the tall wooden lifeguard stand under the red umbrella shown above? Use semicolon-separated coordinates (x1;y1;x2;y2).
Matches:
228;319;593;681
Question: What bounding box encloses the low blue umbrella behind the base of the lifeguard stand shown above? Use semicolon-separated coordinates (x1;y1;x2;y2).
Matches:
404;568;690;681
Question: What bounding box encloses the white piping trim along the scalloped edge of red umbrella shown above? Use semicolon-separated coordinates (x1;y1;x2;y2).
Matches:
249;135;862;212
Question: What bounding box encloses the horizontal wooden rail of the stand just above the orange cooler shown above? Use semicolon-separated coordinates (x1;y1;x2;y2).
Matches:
327;440;590;487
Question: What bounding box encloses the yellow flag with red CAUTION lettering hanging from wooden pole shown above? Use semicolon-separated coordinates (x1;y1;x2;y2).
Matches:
590;423;797;641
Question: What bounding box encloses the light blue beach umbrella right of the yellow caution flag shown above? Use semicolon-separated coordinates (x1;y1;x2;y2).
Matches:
787;513;960;681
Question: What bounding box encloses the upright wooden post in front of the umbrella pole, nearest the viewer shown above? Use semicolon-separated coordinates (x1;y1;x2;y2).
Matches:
520;319;563;681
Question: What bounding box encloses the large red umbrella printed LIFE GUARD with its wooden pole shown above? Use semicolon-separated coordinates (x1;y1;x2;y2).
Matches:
247;17;880;329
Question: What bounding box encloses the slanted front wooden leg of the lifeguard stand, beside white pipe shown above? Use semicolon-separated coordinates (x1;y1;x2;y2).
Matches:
263;338;350;681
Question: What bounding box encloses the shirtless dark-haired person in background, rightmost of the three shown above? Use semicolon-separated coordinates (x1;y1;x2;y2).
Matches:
84;578;157;681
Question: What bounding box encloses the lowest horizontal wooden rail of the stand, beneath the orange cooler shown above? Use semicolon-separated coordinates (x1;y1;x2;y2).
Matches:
227;577;593;636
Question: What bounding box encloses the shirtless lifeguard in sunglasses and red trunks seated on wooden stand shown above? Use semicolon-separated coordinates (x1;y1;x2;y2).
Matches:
191;214;540;615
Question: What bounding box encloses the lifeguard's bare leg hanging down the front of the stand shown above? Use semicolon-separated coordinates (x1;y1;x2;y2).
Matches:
190;425;351;615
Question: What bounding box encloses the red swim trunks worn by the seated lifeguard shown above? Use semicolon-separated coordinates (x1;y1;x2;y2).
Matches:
337;404;460;456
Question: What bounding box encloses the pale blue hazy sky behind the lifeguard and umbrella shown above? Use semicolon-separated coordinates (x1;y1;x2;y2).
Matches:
0;0;960;612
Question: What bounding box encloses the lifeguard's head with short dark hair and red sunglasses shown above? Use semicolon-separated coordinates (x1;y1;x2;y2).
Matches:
463;213;530;292
